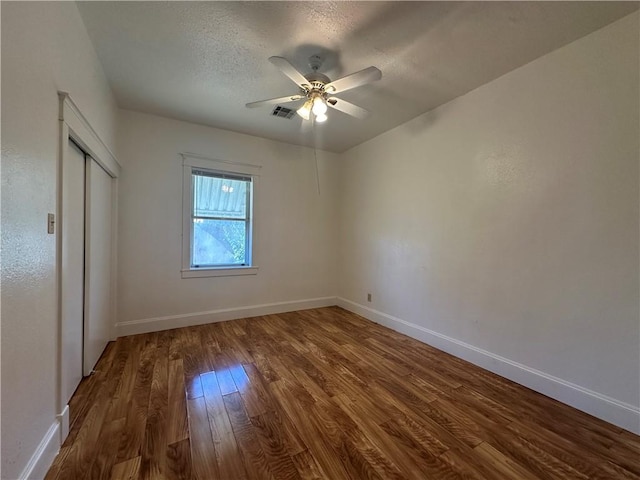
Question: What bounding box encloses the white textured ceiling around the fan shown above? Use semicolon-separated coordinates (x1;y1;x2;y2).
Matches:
78;2;638;152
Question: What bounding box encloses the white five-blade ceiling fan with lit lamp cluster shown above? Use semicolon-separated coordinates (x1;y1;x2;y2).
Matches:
247;55;382;123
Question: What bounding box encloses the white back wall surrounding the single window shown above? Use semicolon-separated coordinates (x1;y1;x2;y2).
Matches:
118;107;337;334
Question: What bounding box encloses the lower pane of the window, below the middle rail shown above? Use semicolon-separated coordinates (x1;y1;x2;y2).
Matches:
191;219;247;266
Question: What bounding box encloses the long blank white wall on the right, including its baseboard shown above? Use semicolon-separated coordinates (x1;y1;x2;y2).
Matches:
339;13;640;433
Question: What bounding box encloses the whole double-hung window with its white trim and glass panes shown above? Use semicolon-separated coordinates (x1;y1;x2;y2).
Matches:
182;155;259;278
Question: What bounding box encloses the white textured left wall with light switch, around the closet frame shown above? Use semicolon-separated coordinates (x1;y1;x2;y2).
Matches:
1;2;116;479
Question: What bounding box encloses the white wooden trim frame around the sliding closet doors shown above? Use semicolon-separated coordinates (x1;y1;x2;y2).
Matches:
56;92;121;444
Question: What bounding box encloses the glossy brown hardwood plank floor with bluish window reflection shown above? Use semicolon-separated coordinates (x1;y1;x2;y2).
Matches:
46;307;640;480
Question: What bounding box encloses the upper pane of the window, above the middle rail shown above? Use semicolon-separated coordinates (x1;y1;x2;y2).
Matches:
193;175;249;219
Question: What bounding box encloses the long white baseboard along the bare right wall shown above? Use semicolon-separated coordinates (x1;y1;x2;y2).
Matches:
336;297;640;435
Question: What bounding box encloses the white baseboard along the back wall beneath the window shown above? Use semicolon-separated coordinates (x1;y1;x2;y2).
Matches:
116;297;336;337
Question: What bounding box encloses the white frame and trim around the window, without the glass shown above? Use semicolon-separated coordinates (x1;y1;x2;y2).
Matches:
181;153;260;278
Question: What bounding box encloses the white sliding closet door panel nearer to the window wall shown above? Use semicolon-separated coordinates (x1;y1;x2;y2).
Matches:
83;156;113;375
